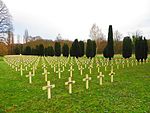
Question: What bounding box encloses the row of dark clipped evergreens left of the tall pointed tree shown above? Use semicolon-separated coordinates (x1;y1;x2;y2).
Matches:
14;39;96;58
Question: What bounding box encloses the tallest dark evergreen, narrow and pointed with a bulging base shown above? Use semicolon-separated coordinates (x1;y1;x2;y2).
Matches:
103;25;114;60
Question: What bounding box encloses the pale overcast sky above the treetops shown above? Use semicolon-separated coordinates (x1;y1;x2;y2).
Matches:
3;0;150;40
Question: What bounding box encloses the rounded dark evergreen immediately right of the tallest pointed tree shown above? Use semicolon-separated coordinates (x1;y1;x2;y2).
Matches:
122;36;132;58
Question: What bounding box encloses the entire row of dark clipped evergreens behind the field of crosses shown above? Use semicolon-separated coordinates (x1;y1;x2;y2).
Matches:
12;25;148;61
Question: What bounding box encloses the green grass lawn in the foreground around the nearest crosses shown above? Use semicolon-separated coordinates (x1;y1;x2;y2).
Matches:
0;57;150;113
